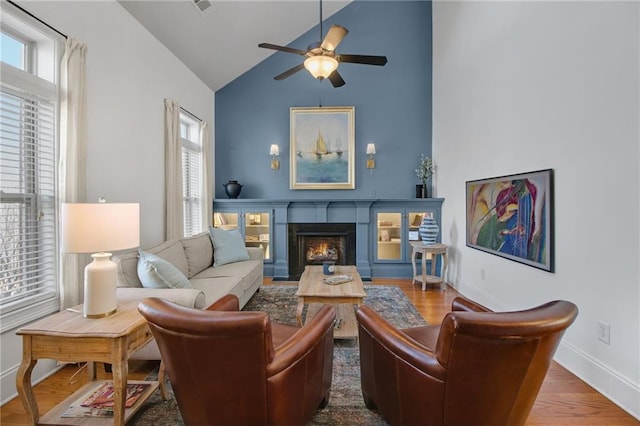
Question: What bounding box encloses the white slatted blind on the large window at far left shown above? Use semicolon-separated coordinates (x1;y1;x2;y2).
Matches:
0;79;57;313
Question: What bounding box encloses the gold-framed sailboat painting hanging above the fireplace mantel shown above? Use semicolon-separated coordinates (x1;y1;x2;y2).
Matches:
289;107;355;189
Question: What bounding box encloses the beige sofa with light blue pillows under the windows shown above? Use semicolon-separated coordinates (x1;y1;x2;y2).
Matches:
114;232;263;359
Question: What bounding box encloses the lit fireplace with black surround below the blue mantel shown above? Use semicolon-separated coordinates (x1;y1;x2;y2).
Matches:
289;223;356;281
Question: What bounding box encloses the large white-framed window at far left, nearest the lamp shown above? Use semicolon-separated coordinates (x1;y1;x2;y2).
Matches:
0;2;62;330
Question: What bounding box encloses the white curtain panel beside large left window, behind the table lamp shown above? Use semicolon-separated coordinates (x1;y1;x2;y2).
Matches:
58;38;87;309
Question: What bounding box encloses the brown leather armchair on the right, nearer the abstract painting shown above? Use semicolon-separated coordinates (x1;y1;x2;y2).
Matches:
357;298;578;426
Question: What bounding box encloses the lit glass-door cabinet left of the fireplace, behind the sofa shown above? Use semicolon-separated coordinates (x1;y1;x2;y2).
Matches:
213;210;272;262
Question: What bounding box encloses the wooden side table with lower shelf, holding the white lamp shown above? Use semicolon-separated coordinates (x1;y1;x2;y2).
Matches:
16;302;166;425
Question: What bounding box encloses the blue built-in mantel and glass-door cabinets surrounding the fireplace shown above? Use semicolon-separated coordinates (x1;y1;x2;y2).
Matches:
213;198;444;280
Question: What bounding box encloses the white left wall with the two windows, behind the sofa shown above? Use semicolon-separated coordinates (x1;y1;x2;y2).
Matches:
0;0;214;402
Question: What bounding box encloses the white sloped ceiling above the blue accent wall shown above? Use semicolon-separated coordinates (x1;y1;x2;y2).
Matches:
118;0;351;91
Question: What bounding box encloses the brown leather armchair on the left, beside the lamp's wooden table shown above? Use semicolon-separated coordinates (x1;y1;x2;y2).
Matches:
138;295;335;426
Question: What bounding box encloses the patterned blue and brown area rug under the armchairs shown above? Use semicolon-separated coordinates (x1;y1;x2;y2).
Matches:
128;285;426;426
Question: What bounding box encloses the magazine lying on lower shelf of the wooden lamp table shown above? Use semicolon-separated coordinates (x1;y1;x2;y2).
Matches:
62;382;151;417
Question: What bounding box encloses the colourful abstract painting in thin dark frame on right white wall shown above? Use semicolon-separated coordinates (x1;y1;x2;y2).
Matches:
466;169;554;272
